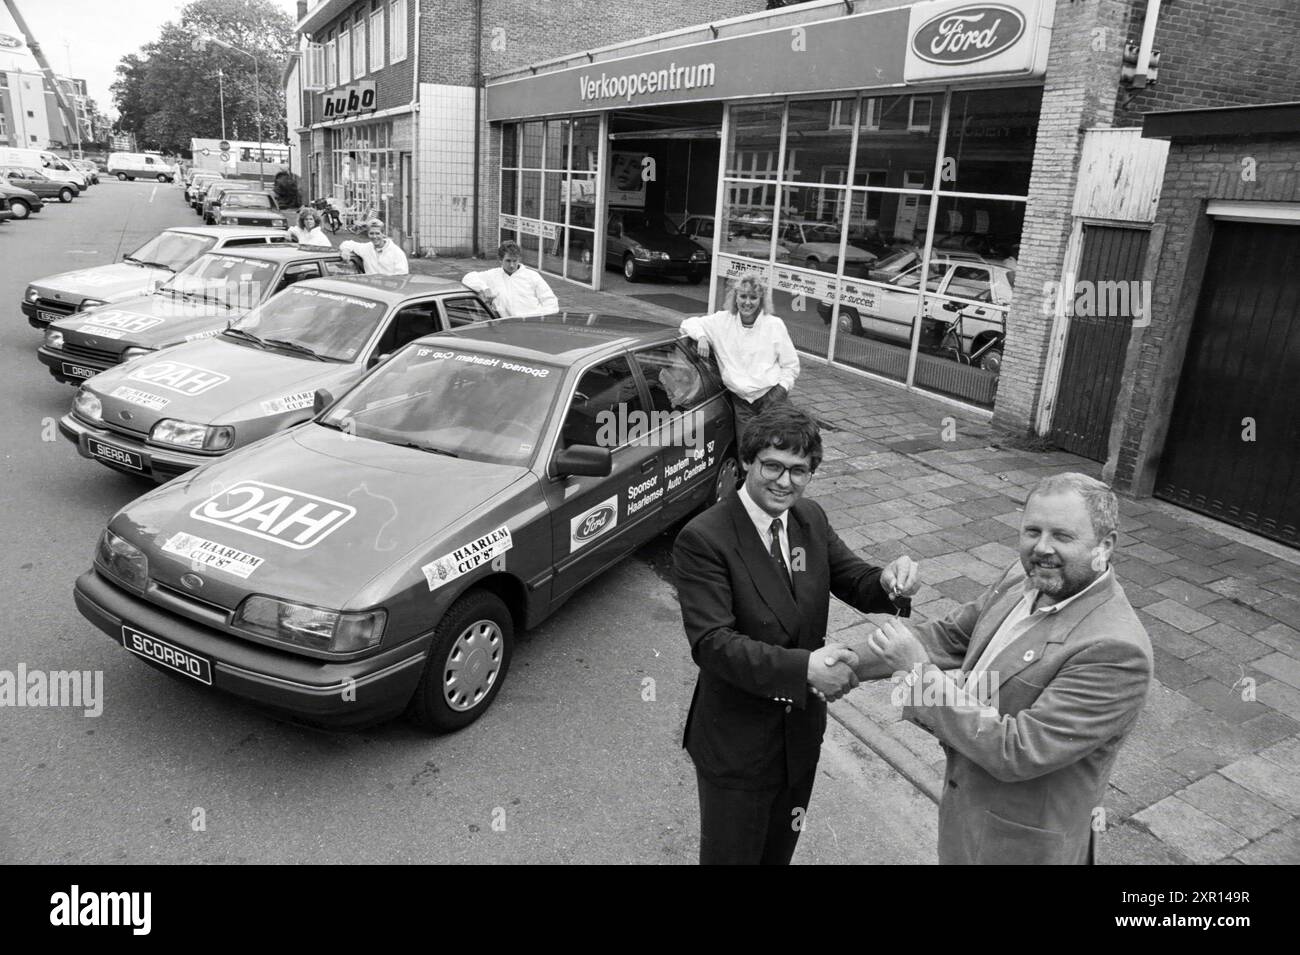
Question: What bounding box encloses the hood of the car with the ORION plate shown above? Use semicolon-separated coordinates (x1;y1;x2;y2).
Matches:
51;295;247;353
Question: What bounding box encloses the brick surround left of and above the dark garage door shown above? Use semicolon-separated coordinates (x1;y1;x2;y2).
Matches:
1113;138;1300;496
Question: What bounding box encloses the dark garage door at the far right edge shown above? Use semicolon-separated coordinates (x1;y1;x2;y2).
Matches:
1156;221;1300;546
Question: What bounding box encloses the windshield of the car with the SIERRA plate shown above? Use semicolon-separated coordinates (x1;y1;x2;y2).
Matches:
225;286;387;361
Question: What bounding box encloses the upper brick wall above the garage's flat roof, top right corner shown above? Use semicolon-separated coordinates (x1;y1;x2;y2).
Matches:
1115;0;1300;126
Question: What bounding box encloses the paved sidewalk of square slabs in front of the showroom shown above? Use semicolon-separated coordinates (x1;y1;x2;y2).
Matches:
412;259;1300;864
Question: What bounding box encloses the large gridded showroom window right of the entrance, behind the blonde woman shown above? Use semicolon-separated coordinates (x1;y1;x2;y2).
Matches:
714;87;1043;408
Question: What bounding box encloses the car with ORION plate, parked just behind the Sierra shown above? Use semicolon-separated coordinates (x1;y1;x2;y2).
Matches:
36;244;356;385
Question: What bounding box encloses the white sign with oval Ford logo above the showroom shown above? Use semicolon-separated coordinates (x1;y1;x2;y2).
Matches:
904;0;1054;82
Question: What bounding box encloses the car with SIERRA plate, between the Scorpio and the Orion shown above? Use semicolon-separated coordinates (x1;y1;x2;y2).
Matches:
60;274;494;481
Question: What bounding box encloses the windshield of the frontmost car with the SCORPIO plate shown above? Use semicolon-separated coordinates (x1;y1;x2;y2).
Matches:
321;342;563;466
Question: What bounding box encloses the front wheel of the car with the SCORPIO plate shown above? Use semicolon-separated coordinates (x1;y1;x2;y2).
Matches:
407;590;515;733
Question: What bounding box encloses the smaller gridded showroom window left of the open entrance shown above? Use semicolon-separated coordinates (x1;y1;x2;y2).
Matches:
498;117;601;285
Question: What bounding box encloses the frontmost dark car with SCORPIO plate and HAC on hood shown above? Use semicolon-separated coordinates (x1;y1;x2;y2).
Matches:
74;310;736;732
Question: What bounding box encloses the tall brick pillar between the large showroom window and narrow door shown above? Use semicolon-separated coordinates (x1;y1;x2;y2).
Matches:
993;0;1128;433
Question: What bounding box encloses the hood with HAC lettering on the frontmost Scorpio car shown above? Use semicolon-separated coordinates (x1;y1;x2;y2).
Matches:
109;424;530;609
